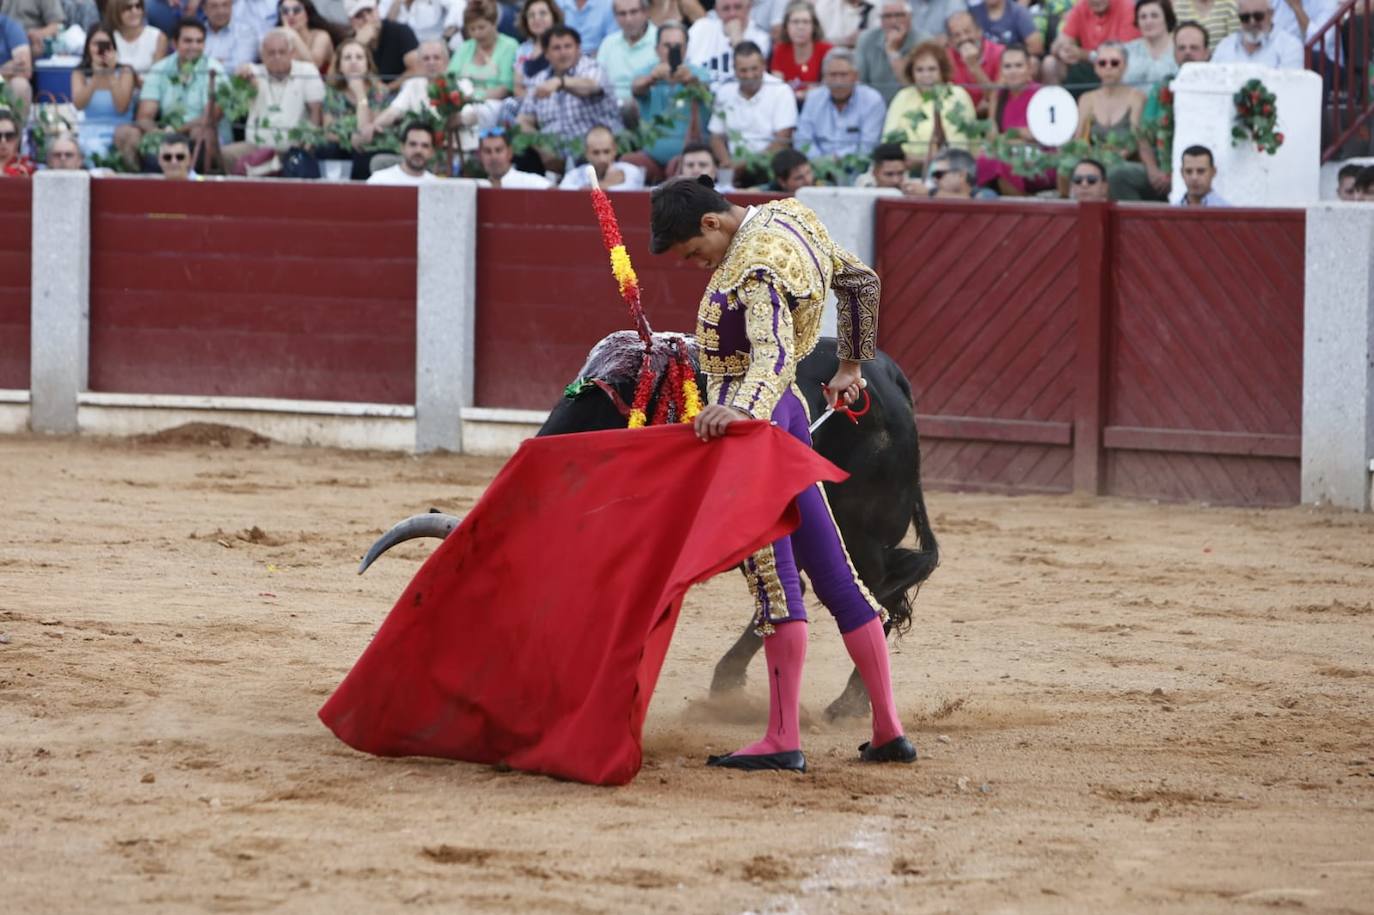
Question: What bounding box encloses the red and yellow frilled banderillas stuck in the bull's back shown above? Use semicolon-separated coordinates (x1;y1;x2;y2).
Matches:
592;184;701;429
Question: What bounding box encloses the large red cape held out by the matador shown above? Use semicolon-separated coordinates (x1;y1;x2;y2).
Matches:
320;422;845;784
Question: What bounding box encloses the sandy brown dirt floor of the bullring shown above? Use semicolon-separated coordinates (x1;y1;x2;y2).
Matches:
0;430;1374;914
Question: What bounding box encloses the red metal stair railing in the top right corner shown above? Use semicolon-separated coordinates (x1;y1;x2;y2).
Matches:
1304;0;1374;162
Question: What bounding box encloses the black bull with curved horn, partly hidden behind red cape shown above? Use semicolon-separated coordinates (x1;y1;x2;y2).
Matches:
359;331;940;719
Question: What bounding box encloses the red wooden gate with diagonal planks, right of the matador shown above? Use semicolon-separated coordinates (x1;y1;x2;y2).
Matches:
877;201;1305;504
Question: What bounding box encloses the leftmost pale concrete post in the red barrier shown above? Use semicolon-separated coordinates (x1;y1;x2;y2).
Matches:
29;172;91;434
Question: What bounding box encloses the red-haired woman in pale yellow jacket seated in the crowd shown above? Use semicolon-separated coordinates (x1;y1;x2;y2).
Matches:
882;41;976;169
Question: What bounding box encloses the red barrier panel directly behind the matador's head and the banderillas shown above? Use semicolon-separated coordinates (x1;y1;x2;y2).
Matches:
474;190;769;409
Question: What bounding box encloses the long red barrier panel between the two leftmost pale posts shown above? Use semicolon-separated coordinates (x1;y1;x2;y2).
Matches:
91;179;416;404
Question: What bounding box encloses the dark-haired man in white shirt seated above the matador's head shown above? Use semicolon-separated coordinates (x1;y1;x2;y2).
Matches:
708;41;797;173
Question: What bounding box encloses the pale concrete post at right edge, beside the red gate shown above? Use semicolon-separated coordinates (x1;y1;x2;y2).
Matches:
1303;203;1374;511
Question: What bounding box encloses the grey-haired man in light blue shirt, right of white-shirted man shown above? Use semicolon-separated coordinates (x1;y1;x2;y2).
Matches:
797;48;888;157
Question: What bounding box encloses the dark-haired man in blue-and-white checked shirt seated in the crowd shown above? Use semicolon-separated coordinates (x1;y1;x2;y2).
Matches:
519;26;621;172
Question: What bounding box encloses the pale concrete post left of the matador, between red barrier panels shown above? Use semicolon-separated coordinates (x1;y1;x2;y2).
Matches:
415;179;477;452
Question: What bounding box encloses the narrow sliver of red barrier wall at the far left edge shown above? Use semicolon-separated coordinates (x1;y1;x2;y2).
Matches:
0;180;33;390
